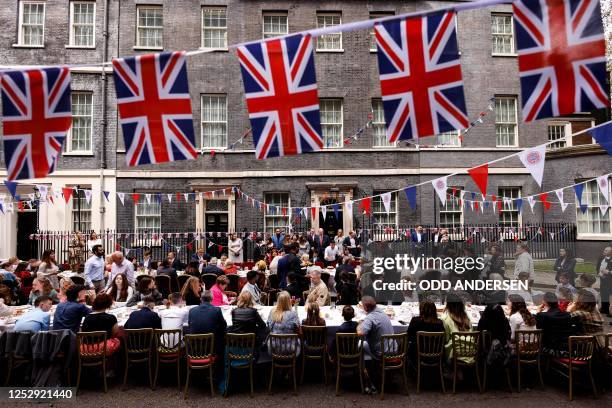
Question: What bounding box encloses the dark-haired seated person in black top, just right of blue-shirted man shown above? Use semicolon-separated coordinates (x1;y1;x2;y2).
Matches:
81;293;121;356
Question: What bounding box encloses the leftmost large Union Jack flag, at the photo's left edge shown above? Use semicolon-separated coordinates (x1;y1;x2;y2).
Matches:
0;68;72;180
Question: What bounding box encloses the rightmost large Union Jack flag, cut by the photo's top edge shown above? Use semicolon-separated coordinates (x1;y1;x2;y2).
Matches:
512;0;609;122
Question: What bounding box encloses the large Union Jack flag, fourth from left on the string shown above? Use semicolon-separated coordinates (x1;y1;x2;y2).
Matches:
374;11;469;142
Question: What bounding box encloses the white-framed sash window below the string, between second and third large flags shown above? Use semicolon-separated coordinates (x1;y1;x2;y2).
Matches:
202;95;227;148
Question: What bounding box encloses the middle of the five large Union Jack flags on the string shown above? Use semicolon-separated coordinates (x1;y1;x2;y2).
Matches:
237;34;323;160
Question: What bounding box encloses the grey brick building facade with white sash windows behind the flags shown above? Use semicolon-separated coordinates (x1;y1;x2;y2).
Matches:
0;0;612;257
